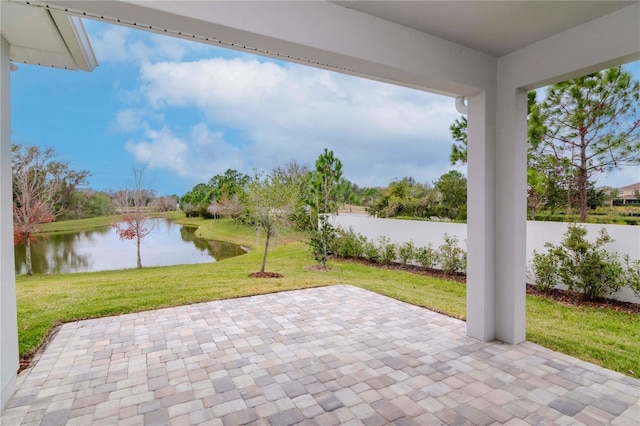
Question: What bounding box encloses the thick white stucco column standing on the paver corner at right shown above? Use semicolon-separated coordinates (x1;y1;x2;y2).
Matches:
467;79;527;344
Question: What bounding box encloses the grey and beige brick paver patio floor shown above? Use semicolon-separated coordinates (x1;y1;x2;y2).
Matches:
1;286;640;426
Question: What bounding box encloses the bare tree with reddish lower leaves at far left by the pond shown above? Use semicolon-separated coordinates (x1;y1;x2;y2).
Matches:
11;145;89;275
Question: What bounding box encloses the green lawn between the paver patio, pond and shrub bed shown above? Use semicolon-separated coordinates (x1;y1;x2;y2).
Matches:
17;218;640;377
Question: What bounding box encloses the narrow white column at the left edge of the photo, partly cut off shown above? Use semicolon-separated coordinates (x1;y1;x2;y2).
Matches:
0;35;19;408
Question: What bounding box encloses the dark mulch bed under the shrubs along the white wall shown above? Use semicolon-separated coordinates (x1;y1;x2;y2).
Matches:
337;258;640;315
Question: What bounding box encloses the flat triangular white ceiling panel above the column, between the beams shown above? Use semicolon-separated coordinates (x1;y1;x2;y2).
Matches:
332;0;640;58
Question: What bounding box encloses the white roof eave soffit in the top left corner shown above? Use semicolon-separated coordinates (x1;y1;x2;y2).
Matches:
0;1;98;71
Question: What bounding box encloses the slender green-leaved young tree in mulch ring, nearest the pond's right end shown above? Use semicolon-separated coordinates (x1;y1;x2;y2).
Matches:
247;173;299;274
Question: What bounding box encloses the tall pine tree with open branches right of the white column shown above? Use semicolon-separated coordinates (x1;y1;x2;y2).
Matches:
540;67;640;222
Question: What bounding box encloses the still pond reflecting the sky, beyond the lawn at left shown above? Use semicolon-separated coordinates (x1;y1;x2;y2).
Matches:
15;219;245;274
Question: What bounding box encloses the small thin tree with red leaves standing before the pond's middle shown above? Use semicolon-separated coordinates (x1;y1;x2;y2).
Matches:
113;167;154;268
